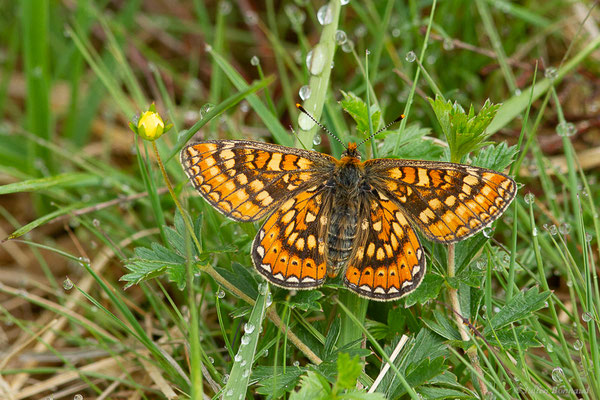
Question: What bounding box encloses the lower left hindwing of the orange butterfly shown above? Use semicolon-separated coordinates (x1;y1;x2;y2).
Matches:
252;183;331;289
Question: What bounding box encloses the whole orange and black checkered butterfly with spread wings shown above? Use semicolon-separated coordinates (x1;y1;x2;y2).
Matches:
181;107;516;301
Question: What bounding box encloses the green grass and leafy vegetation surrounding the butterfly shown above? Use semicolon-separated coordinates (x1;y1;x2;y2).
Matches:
0;0;600;399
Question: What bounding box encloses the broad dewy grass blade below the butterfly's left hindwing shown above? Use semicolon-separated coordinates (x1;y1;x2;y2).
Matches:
223;283;269;400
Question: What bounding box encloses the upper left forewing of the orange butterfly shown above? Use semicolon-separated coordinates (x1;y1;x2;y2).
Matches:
181;140;335;222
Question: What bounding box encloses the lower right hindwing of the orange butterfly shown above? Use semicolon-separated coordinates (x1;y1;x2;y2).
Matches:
344;194;425;301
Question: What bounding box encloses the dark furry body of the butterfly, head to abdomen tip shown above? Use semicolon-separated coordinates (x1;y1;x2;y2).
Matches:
327;143;369;277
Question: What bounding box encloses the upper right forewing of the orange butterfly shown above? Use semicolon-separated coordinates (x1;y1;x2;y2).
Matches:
365;159;517;243
